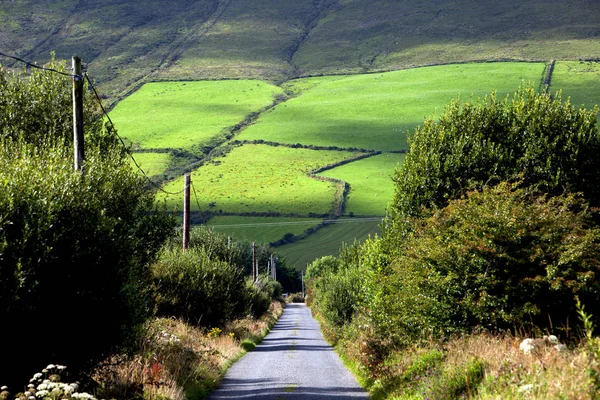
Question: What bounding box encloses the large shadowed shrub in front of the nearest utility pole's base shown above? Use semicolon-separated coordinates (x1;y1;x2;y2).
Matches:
0;142;172;384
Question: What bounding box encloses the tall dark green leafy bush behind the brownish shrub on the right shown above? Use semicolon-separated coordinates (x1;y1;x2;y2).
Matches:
386;87;600;235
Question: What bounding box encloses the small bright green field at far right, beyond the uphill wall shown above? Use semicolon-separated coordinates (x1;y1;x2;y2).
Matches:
550;61;600;108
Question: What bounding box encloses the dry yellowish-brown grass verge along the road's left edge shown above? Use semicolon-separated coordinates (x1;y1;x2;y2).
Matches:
94;302;283;400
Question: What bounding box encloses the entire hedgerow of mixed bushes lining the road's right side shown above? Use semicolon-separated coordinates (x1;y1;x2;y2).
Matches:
307;88;600;398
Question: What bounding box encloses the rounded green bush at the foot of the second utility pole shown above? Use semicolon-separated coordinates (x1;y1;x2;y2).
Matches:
152;246;246;326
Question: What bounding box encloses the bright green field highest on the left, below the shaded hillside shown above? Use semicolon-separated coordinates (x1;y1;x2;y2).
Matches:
110;80;283;149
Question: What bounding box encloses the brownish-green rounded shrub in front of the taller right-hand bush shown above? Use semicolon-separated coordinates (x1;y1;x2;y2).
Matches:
376;183;600;340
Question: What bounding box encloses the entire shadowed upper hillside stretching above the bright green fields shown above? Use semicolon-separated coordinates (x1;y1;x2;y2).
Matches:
0;0;600;95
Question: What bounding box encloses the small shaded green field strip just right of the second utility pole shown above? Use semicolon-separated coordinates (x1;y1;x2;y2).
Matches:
207;216;321;244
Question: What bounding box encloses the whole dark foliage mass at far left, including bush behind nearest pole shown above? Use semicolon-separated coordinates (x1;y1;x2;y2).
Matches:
0;63;173;383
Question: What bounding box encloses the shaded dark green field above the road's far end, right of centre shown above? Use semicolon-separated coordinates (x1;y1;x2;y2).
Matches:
276;218;381;269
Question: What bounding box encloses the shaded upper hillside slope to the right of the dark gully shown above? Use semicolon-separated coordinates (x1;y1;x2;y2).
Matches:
295;0;600;74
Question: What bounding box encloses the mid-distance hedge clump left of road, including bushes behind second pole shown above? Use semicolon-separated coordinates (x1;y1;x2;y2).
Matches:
152;227;286;327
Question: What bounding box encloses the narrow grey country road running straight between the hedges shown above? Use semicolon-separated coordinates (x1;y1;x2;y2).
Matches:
209;304;369;400
